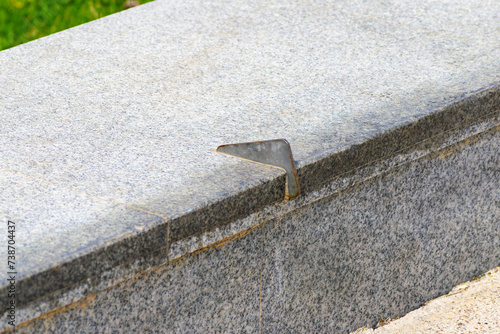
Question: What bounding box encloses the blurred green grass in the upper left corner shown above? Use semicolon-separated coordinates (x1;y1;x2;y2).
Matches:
0;0;152;50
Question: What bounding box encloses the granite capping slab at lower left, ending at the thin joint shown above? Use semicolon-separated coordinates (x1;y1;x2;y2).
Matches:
0;170;167;312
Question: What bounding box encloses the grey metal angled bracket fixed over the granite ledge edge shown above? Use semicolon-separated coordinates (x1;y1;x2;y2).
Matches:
217;139;299;199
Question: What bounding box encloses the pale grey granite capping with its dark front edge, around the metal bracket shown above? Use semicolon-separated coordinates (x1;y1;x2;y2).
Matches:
0;0;500;328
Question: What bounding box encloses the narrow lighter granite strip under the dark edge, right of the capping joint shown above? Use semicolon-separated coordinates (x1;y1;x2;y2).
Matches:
168;113;500;260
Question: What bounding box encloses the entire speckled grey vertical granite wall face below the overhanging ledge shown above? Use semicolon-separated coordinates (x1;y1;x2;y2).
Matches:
10;127;500;333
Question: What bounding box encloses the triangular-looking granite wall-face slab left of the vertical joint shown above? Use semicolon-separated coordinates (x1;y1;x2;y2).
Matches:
14;222;262;333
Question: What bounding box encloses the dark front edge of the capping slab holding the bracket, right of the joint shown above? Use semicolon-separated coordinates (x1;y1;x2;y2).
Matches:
169;84;500;244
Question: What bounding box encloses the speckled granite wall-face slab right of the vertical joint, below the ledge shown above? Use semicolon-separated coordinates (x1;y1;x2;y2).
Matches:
261;126;500;333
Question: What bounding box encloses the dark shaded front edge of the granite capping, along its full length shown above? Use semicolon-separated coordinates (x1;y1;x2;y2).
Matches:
0;86;500;324
